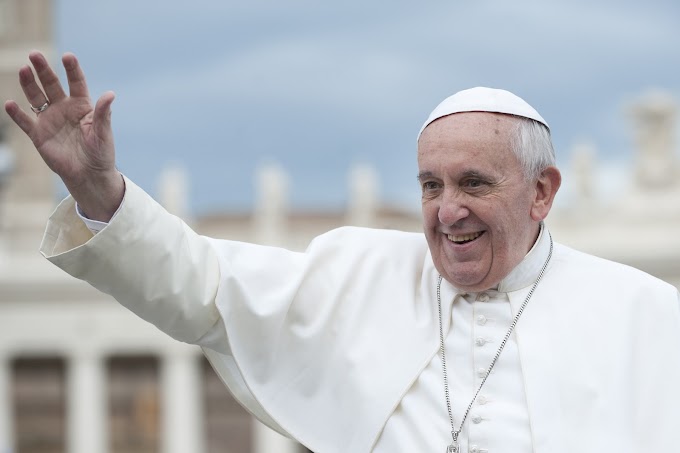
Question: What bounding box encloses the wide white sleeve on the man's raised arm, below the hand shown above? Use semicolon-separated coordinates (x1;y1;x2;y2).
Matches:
40;175;220;347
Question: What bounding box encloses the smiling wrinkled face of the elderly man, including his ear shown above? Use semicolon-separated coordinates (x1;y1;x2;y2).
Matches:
418;112;559;292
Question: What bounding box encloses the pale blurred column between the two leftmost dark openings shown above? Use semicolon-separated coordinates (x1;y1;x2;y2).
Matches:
67;353;108;453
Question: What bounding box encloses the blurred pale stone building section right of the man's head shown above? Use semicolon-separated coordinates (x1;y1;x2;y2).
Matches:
547;91;680;288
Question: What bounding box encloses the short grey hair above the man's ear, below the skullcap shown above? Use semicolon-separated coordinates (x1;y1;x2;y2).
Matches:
511;116;555;181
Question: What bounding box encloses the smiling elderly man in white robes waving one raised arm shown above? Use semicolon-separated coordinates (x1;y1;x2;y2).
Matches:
5;53;680;453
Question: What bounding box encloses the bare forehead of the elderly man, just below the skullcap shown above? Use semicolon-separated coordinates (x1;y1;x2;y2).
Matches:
418;112;518;166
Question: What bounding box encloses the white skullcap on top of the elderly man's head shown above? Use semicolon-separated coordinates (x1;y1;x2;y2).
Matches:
418;87;550;139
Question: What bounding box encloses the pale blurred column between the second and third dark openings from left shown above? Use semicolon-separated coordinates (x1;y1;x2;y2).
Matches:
161;347;205;453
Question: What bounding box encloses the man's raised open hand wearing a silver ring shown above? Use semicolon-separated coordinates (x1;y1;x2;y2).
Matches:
5;52;125;222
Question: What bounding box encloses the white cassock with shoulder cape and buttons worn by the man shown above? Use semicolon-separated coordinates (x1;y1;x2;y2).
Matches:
41;180;680;453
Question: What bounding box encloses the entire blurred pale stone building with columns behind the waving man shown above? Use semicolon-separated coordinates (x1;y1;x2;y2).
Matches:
0;0;680;453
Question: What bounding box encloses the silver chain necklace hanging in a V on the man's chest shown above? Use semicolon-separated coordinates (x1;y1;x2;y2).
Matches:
437;233;553;453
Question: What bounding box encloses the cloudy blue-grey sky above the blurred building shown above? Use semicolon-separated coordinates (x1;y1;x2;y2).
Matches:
55;0;680;215
